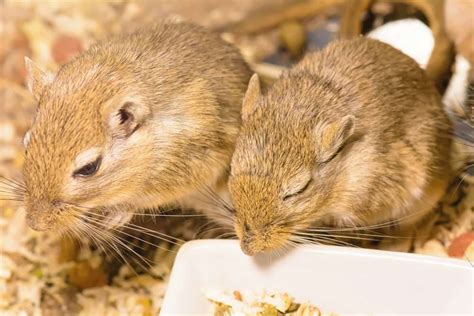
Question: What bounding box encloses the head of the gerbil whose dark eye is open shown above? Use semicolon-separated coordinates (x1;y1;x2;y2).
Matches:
23;58;151;230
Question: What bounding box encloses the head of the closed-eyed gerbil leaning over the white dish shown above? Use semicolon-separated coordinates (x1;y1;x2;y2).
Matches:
229;75;355;255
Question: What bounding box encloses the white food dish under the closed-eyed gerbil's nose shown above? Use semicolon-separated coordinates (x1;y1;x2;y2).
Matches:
161;240;474;315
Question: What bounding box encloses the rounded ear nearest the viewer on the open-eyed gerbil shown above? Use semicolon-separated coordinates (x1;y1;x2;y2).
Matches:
105;98;151;138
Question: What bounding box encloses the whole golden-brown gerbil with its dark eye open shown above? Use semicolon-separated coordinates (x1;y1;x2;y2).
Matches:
23;22;251;230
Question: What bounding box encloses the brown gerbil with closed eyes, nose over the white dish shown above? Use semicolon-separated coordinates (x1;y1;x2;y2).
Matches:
229;38;451;255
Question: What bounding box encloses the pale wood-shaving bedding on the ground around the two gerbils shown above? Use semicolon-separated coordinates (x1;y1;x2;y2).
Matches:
0;1;474;315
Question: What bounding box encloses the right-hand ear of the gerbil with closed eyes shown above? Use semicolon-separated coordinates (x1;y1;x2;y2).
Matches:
316;115;355;162
